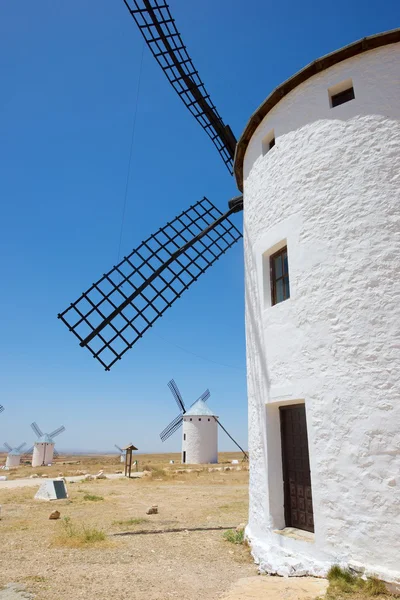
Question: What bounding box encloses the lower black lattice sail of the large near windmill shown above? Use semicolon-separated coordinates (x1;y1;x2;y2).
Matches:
58;197;243;371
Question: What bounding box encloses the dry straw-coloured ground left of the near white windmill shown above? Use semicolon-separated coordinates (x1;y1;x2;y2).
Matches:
0;453;256;600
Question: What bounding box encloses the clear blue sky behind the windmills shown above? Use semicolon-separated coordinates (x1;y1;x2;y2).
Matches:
0;0;400;451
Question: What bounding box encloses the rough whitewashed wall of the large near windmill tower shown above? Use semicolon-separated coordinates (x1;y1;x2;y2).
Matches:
244;44;400;582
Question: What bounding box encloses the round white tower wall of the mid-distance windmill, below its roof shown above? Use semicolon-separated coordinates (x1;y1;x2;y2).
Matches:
182;415;218;465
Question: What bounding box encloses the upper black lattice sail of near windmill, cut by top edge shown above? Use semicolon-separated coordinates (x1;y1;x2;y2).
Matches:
124;0;236;174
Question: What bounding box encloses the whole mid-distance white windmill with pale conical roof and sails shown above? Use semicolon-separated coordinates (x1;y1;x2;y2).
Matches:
160;379;248;464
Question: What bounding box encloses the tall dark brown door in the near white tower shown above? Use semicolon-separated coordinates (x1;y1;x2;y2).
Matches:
280;404;314;531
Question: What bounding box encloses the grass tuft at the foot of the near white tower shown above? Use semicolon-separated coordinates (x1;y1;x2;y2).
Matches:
326;565;391;600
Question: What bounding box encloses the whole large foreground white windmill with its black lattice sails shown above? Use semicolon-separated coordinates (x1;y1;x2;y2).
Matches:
52;0;400;581
